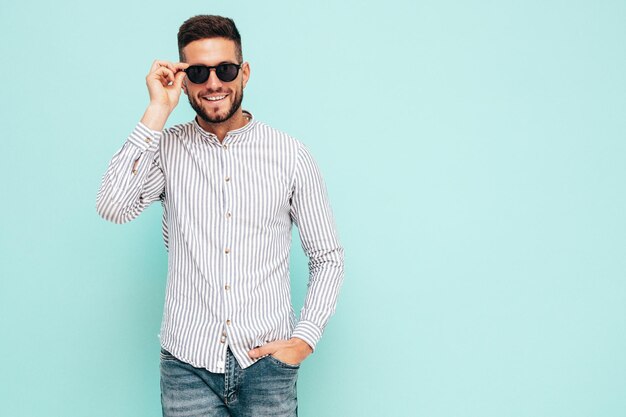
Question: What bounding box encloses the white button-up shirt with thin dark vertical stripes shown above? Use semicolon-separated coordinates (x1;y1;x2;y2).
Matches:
96;112;343;373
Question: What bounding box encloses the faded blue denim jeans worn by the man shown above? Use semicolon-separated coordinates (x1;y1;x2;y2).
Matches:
161;349;299;417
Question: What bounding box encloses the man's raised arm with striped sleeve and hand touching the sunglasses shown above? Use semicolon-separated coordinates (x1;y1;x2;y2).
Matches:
96;61;188;223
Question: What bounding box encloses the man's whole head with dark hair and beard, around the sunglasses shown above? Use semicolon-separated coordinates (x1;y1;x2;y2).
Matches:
178;15;250;123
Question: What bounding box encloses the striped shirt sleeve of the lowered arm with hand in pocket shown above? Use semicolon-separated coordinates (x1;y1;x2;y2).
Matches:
290;144;344;349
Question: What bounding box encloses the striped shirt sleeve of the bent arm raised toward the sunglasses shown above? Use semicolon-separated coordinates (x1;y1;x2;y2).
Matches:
96;123;165;223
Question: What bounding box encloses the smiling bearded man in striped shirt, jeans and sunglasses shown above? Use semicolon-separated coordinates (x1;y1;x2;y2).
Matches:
97;16;343;416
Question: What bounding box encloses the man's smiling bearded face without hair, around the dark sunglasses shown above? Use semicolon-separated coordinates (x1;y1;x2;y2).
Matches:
183;38;250;123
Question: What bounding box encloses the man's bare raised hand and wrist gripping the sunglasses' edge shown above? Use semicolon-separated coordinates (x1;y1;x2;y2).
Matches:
141;61;189;130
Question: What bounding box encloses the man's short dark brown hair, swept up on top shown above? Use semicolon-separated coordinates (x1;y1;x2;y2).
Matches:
178;15;243;62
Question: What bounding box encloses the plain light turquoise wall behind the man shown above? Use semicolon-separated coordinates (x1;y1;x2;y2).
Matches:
0;0;626;417
